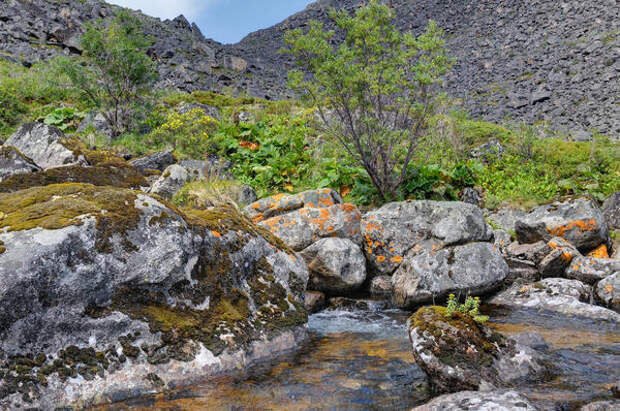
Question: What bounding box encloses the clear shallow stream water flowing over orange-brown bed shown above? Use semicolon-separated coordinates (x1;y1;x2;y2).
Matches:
99;308;620;410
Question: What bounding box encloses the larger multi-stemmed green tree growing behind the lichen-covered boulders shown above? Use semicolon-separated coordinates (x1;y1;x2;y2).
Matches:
283;0;451;200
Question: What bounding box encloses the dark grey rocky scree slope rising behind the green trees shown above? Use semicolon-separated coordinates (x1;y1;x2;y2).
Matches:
0;0;620;139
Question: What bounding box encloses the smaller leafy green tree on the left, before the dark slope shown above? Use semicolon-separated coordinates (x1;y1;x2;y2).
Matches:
61;11;157;137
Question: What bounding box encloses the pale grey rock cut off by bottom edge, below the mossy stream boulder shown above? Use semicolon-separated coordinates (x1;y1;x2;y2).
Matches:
412;390;538;411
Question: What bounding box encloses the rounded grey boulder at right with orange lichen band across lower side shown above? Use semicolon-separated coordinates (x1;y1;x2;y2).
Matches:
515;198;609;253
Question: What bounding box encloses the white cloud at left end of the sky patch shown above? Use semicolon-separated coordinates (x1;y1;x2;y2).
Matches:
108;0;218;22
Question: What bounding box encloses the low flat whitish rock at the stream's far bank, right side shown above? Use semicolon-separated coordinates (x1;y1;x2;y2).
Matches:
489;278;620;322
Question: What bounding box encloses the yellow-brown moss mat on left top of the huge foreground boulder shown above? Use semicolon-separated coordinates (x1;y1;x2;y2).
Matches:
0;183;142;252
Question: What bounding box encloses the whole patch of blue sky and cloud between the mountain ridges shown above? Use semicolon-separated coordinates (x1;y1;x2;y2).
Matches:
107;0;313;43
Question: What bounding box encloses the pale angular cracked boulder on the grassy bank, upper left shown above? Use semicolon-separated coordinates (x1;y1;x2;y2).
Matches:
4;123;86;169
